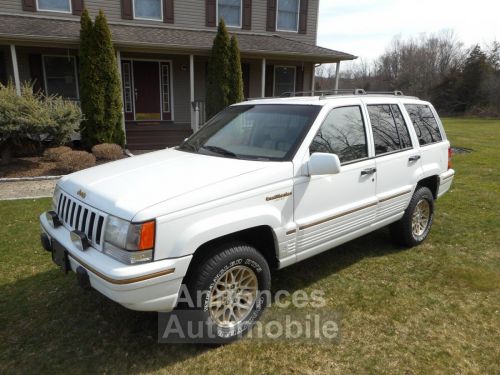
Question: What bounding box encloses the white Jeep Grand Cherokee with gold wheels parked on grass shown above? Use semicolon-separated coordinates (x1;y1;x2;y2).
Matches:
40;93;454;338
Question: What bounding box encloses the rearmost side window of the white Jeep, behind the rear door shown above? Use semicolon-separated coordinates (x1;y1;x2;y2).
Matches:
405;104;443;146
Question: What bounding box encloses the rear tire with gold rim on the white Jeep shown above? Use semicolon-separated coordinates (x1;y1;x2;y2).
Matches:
389;186;434;247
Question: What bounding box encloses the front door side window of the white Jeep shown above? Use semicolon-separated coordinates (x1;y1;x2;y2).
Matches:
309;106;368;163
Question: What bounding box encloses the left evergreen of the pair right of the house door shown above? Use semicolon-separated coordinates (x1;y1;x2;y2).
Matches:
206;19;231;119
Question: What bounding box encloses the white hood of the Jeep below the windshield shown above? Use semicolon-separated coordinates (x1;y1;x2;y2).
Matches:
58;149;280;220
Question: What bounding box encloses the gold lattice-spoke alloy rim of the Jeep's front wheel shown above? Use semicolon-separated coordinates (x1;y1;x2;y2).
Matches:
209;266;258;327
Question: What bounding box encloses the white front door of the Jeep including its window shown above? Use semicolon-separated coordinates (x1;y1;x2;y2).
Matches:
294;105;377;260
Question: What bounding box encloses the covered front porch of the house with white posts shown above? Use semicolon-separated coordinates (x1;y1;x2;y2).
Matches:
0;15;355;149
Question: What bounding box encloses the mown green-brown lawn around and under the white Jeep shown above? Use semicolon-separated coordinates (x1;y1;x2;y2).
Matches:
0;119;500;375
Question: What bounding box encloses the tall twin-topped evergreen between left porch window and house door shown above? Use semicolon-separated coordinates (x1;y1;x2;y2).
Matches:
80;9;124;148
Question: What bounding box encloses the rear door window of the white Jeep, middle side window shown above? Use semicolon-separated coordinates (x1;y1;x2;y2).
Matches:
367;104;411;155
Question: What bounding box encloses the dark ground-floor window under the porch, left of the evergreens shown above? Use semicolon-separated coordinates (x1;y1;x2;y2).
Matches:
43;56;79;100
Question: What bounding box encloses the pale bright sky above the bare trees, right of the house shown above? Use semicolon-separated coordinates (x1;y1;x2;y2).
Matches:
318;0;500;64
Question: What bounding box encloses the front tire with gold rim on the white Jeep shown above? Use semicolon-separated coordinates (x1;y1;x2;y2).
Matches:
188;242;271;343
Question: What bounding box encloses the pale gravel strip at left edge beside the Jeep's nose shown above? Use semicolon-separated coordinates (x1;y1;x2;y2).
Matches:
0;180;57;200
